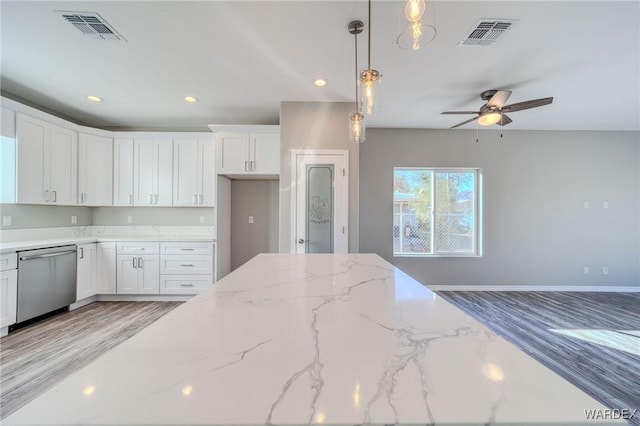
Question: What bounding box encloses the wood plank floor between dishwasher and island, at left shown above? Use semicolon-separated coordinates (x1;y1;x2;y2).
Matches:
0;302;180;419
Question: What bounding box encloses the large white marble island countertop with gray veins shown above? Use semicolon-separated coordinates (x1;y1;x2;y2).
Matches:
3;254;611;425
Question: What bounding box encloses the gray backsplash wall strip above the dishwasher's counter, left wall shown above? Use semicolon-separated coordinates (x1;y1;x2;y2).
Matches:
0;204;93;229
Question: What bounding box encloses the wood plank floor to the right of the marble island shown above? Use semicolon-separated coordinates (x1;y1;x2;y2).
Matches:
438;291;640;426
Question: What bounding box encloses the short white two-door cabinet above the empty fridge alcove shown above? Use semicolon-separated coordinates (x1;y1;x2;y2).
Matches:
214;129;280;178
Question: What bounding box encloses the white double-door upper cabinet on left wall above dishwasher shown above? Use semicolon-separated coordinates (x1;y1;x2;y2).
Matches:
16;114;78;205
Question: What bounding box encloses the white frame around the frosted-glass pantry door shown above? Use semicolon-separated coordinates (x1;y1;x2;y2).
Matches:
289;149;349;253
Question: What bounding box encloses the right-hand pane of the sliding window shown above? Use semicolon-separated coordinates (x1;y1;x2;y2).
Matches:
434;171;476;253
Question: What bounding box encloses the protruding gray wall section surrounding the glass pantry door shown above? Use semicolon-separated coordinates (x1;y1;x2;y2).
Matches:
280;102;359;253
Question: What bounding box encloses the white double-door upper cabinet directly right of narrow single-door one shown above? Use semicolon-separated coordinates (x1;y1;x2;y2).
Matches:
133;139;173;206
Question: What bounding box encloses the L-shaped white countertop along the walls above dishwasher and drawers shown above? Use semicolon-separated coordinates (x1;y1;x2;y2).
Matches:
0;226;215;253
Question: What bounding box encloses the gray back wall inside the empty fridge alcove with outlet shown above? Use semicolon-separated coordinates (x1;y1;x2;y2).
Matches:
231;180;279;270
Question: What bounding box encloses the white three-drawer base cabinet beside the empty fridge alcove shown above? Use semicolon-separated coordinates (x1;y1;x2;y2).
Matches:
160;242;214;295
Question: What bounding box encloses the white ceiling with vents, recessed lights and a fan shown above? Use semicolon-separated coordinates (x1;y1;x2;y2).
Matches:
0;0;640;130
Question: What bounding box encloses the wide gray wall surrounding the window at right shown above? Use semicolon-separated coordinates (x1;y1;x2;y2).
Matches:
360;129;640;286
